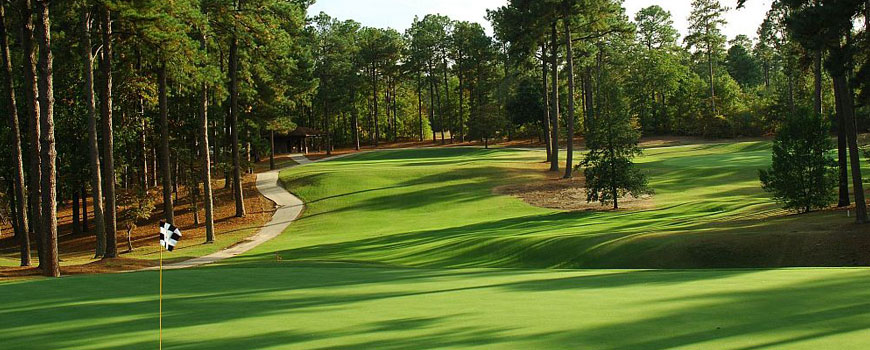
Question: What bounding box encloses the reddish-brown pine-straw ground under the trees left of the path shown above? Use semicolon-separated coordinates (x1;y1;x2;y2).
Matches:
0;171;275;277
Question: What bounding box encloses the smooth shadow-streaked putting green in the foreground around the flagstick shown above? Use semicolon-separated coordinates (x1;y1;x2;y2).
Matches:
0;262;870;350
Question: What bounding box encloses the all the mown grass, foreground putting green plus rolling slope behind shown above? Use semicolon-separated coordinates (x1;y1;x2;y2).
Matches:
0;142;870;350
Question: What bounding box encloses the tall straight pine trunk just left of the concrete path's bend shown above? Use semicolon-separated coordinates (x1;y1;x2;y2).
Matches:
230;35;245;217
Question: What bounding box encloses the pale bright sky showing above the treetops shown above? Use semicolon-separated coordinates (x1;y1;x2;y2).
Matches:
309;0;771;39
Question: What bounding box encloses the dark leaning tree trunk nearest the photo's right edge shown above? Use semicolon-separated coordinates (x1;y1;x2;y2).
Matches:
833;72;867;223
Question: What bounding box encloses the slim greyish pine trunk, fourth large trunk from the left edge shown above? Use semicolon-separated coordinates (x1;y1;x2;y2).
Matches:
81;10;106;258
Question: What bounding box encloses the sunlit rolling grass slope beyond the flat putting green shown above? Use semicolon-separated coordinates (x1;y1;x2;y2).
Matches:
240;142;870;268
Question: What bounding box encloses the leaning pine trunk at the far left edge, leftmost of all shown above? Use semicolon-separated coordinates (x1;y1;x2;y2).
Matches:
0;3;30;266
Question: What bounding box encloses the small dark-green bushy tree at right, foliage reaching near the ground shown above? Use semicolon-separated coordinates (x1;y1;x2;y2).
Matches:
759;112;837;213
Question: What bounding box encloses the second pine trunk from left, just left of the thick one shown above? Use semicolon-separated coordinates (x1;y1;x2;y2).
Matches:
20;0;45;268
